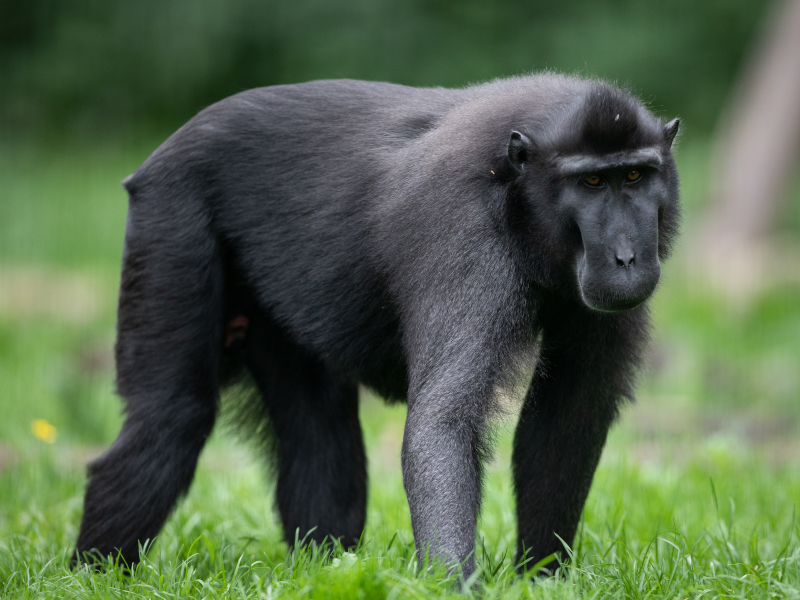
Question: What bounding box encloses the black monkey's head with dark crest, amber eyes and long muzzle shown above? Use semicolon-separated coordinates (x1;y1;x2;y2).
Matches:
507;88;680;312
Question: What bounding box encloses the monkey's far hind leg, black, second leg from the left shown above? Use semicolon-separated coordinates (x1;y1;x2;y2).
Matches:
248;322;367;546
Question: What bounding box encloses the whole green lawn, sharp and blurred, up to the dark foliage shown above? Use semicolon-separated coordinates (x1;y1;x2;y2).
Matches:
0;140;800;599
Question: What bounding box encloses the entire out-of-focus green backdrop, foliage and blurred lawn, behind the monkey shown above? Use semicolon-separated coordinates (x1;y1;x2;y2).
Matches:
0;0;800;596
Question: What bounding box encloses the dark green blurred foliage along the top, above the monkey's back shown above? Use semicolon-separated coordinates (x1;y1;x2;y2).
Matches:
0;0;765;136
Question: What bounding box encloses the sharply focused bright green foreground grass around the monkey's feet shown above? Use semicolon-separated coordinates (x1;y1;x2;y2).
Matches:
0;424;800;598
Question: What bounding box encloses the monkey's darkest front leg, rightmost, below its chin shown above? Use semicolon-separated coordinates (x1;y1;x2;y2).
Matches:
512;312;647;571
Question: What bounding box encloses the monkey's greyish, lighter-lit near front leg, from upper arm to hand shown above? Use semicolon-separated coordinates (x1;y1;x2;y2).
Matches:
402;254;531;578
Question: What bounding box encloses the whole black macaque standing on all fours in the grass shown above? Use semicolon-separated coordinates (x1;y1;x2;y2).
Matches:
77;74;679;575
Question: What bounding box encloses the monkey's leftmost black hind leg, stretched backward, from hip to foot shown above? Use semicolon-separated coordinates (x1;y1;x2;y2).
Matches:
76;193;223;564
